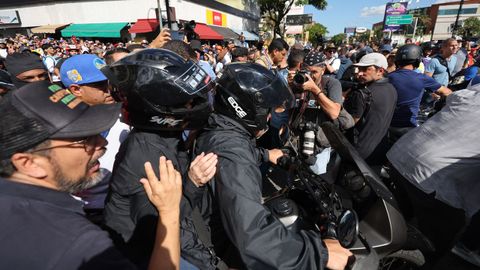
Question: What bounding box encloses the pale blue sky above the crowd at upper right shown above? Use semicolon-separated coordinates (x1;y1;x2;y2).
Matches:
305;0;449;36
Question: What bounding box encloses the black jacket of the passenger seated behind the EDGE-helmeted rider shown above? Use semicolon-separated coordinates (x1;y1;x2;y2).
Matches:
105;129;218;269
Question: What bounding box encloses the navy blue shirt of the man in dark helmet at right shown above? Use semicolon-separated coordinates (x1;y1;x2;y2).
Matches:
388;69;442;127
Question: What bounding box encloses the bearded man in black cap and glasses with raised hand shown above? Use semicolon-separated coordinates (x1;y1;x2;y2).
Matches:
0;82;181;270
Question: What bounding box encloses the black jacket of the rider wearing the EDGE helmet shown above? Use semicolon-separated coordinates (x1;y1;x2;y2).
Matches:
196;114;328;270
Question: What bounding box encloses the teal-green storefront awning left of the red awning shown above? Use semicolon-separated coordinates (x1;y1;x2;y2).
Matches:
62;22;127;38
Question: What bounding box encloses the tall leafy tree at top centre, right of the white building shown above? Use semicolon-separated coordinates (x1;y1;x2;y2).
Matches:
258;0;327;37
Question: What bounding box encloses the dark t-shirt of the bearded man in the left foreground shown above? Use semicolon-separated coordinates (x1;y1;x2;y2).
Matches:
0;178;135;270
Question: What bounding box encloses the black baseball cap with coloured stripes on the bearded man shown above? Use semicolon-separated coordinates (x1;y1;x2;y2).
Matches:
0;81;121;159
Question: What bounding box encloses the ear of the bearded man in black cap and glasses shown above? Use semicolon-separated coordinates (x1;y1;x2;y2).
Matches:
10;153;48;179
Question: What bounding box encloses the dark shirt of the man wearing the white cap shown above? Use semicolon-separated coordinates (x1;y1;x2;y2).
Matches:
344;79;397;158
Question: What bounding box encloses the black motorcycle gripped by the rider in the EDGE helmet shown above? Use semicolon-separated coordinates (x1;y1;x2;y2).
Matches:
264;122;424;270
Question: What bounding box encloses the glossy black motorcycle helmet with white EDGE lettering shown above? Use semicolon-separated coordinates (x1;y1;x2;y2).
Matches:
214;63;295;135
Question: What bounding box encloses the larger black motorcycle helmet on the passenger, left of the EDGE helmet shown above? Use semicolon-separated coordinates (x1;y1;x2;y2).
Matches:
102;49;214;131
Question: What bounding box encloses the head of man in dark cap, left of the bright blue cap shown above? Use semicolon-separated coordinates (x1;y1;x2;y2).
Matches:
5;52;48;88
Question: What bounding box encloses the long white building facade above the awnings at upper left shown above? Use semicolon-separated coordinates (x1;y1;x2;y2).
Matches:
0;0;260;40
